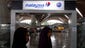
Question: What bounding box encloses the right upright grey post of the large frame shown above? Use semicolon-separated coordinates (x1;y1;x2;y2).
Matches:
70;11;77;48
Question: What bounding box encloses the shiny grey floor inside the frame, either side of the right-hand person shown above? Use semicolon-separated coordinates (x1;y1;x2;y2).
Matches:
27;32;68;48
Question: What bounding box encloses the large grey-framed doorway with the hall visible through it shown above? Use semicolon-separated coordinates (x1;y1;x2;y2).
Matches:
10;10;77;48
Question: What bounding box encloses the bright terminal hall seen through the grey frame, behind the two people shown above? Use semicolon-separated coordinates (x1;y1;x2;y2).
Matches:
16;13;71;48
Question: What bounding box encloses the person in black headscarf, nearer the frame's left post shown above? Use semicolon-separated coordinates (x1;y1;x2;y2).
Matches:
12;27;29;48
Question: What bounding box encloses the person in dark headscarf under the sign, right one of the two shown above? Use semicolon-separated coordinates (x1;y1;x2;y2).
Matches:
39;26;52;48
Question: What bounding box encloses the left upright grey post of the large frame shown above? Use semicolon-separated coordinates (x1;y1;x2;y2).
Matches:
10;10;16;48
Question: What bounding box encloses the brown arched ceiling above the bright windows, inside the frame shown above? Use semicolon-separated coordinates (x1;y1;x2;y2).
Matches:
16;13;71;23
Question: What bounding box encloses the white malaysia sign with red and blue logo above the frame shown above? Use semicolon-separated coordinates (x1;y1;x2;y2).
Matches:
23;1;64;10
